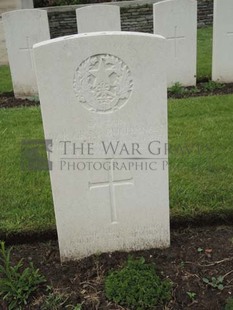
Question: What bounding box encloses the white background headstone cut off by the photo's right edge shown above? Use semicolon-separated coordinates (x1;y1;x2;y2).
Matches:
212;0;233;83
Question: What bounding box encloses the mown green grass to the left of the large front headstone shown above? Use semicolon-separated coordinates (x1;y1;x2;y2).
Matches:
0;108;55;232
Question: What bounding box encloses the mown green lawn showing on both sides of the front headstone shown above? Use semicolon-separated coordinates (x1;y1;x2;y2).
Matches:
0;95;233;232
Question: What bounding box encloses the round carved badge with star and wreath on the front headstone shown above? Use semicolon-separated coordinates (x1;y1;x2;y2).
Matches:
74;54;133;113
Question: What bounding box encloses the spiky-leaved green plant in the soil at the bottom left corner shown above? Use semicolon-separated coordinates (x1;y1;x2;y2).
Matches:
0;242;45;310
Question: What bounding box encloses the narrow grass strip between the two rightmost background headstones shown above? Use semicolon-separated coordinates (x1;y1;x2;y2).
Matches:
197;27;213;80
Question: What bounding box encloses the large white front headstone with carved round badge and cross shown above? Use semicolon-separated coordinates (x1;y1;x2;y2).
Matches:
34;32;170;261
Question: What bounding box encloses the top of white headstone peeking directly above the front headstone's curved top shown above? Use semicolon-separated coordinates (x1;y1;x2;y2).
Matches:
76;4;121;33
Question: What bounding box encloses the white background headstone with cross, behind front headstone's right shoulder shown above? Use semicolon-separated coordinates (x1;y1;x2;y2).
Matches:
153;0;197;86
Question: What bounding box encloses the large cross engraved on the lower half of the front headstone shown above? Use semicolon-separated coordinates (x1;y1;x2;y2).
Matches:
89;159;134;224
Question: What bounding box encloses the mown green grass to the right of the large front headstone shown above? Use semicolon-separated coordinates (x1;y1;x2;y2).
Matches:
169;95;233;218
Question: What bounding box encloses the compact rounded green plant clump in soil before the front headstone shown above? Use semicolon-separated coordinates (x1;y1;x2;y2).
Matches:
105;257;172;310
